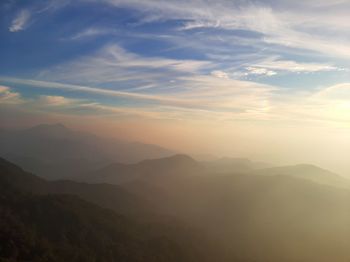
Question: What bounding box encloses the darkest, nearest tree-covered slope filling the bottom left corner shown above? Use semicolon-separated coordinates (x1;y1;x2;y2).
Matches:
0;159;224;262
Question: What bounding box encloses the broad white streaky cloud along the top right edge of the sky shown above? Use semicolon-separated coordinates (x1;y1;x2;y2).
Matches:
94;0;350;57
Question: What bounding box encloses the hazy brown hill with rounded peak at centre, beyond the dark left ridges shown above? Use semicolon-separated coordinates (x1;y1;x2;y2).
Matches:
82;155;205;185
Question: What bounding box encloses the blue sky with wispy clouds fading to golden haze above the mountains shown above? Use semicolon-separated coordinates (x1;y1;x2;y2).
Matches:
0;0;350;176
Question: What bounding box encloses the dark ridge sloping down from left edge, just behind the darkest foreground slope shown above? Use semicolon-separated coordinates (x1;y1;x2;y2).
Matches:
0;159;154;216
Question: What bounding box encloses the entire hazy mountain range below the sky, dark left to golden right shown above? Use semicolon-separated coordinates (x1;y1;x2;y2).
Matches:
0;125;350;262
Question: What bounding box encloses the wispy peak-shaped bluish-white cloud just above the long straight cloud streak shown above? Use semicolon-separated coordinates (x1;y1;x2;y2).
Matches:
39;44;212;89
